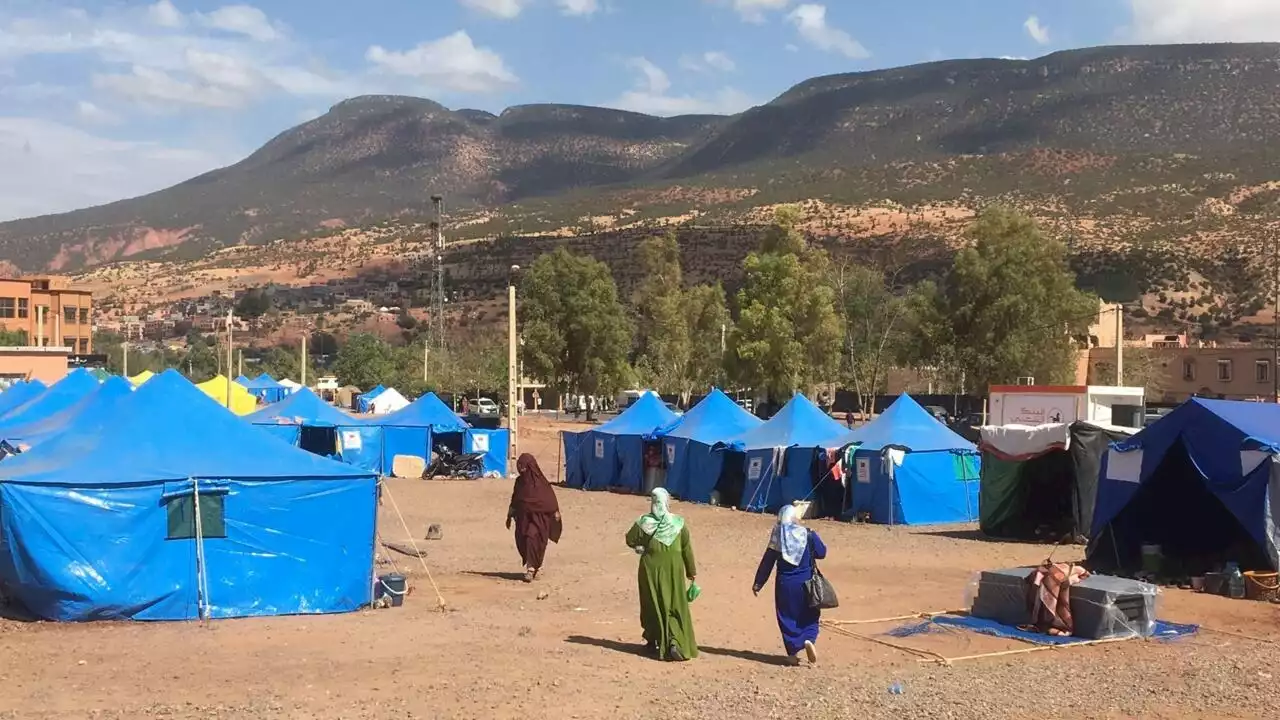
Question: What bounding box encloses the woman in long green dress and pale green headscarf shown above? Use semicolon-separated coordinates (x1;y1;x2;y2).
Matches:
627;488;698;661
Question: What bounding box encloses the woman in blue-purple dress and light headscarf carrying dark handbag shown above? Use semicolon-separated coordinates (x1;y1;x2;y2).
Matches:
751;505;827;664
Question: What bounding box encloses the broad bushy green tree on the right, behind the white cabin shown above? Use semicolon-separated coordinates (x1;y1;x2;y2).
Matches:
911;206;1098;388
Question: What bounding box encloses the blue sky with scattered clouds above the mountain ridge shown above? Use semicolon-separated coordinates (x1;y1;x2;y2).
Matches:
0;0;1280;219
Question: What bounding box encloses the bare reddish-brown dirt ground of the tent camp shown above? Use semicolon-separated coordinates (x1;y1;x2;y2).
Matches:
0;419;1280;720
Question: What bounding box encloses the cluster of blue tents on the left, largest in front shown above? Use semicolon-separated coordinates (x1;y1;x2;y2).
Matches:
0;370;507;620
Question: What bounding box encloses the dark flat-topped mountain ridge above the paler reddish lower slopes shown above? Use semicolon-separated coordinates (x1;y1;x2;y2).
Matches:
0;44;1280;270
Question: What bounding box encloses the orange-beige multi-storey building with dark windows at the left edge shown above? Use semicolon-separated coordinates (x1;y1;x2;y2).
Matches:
0;277;93;355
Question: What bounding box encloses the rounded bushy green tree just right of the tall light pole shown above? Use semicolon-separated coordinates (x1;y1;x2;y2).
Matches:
518;247;632;393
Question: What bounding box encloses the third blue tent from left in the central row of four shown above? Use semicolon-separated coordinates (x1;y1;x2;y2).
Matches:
723;393;849;512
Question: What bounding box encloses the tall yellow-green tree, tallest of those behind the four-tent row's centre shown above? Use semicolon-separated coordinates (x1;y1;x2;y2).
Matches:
733;209;841;400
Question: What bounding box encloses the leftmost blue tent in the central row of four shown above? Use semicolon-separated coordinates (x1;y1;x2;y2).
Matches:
564;392;678;492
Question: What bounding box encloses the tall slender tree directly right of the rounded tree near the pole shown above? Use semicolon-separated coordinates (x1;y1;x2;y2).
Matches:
632;232;690;393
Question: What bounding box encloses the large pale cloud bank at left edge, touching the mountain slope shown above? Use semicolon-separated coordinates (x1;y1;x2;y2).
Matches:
0;118;234;220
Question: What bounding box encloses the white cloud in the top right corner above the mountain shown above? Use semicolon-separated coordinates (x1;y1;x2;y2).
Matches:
1125;0;1280;42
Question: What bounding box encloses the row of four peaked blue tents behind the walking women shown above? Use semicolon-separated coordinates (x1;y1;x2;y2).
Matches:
563;389;979;524
